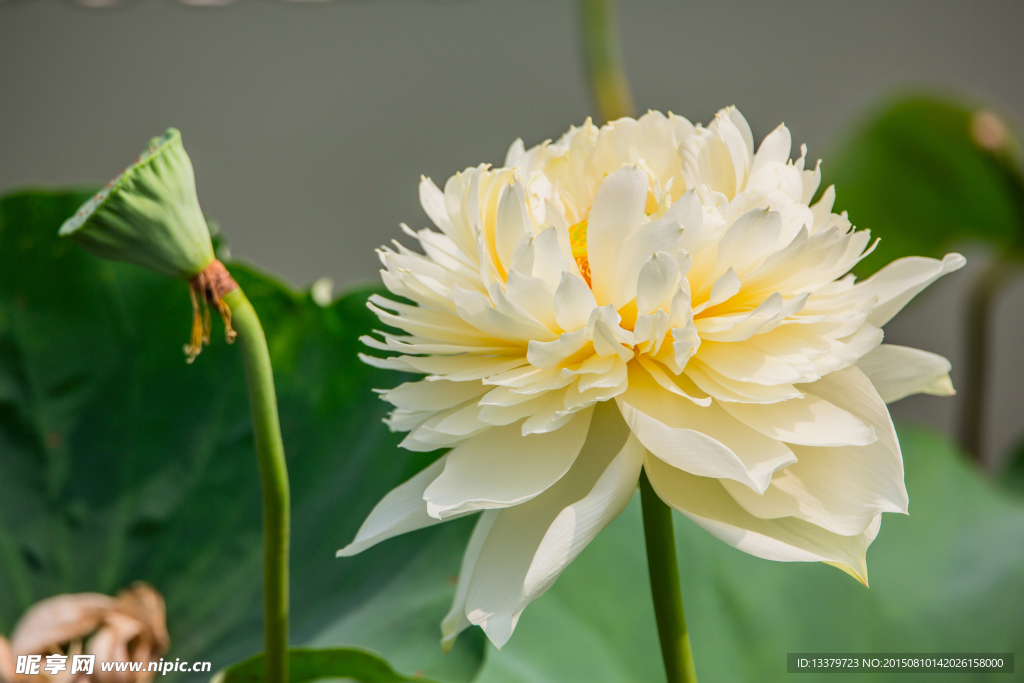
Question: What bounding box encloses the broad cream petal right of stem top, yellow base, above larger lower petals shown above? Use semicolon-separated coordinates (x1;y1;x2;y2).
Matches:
615;364;797;493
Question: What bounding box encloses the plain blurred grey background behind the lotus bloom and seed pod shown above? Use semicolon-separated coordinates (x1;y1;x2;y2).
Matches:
6;0;1024;464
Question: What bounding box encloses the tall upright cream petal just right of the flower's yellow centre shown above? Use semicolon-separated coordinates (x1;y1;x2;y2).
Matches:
587;167;647;305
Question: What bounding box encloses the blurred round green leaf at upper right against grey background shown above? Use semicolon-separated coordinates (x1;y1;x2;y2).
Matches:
821;97;1024;275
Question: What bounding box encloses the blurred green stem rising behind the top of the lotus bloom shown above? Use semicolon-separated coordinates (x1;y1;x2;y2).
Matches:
580;0;636;121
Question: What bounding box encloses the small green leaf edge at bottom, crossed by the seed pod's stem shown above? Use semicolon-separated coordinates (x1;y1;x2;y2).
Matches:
211;647;440;683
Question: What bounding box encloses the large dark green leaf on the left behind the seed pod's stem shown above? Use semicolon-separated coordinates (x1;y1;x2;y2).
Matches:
0;193;482;681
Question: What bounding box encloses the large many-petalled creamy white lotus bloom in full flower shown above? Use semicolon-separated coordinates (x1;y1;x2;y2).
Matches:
338;108;964;647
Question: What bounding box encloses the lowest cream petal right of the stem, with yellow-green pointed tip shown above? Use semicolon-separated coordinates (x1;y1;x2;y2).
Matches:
644;455;881;585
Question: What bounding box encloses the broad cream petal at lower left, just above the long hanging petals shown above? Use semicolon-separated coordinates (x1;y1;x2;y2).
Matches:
423;409;593;519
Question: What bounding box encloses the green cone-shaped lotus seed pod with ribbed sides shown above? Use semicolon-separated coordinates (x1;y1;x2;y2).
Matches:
60;128;215;280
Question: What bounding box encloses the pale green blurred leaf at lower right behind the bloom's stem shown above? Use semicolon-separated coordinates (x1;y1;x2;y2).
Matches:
477;428;1024;683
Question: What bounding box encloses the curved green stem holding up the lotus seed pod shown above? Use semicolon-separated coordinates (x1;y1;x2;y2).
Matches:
223;288;291;683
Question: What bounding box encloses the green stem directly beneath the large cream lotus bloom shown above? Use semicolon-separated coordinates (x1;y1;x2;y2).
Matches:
640;471;697;683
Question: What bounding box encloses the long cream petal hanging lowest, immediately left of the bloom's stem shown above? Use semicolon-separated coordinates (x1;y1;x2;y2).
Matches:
458;405;644;647
